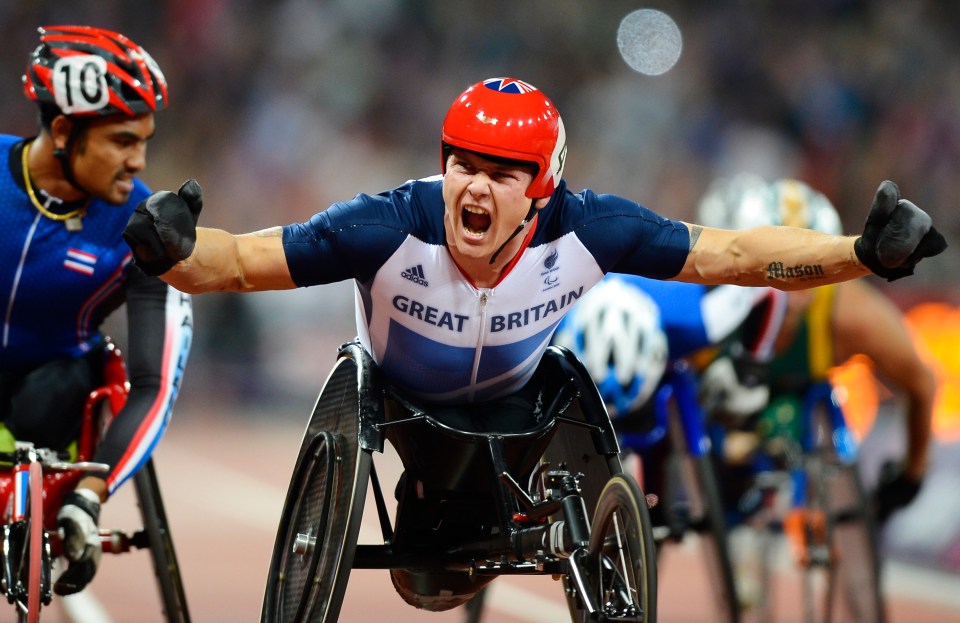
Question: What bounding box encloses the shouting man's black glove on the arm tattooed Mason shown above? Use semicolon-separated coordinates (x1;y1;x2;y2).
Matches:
853;180;947;281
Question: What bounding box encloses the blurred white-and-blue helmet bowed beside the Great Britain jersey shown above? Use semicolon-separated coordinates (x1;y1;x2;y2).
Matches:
554;275;669;419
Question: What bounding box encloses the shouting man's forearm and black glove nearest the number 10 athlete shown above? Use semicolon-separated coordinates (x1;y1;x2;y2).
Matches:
123;180;296;294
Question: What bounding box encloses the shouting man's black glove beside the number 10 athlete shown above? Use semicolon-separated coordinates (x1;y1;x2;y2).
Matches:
123;179;203;276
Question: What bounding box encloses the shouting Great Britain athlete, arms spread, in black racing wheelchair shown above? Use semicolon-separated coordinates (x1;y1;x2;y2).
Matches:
124;78;946;621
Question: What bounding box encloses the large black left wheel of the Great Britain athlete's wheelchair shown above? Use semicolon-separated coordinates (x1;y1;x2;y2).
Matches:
262;358;372;623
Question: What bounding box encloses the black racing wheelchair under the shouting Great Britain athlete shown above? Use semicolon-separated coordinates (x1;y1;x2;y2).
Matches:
262;342;657;623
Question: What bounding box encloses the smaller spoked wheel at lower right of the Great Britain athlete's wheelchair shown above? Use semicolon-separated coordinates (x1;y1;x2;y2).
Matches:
567;474;657;623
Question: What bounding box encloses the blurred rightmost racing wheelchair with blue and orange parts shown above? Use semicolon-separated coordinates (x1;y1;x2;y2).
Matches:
716;381;887;623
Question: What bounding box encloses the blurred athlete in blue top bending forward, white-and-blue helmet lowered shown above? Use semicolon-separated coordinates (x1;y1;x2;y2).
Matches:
554;273;787;420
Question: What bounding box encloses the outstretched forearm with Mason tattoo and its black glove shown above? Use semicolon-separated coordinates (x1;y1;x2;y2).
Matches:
675;182;947;290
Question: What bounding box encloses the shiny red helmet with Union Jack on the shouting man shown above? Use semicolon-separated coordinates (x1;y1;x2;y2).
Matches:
440;78;567;199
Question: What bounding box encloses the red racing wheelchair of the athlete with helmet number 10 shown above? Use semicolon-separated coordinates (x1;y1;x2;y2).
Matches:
0;338;190;623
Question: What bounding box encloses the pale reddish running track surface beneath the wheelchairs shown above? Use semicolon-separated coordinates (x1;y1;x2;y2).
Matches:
30;412;960;623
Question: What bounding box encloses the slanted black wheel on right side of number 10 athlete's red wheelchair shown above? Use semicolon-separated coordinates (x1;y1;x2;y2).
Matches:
133;459;190;623
